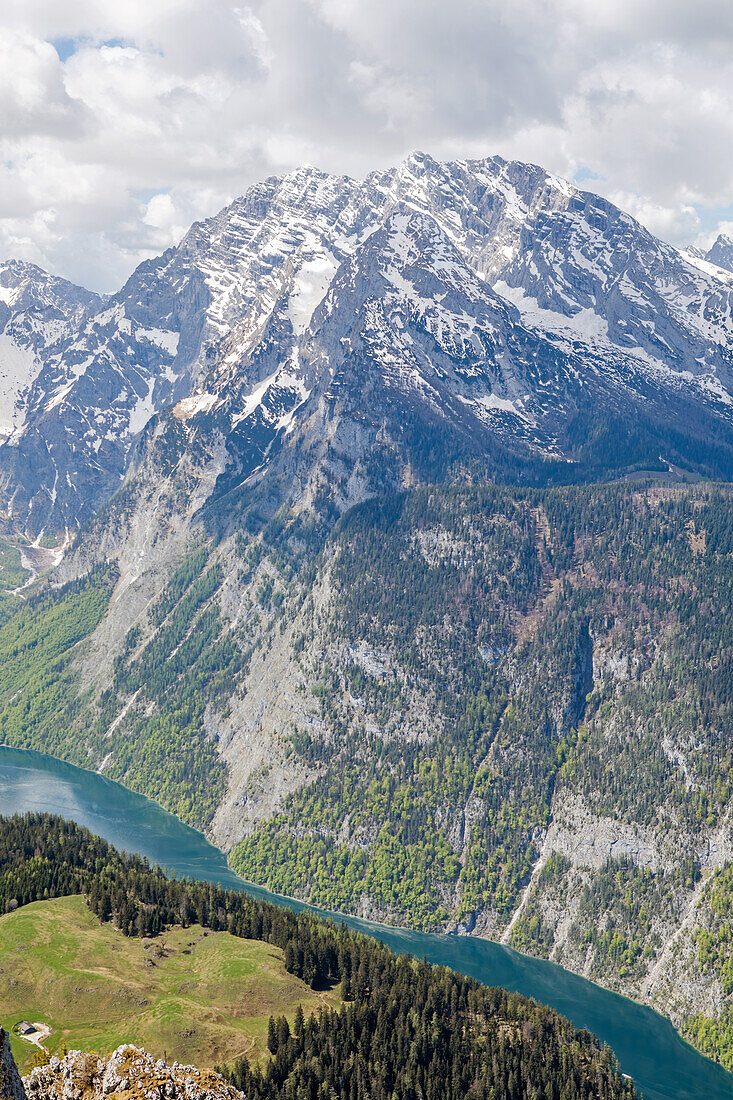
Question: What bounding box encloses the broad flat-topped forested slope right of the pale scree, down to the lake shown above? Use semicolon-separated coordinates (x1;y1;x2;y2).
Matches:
226;485;733;1059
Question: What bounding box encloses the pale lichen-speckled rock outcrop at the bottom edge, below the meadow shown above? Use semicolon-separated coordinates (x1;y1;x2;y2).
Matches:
21;1045;242;1100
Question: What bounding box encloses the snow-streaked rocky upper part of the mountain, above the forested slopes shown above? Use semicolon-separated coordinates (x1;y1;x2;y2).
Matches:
0;154;733;535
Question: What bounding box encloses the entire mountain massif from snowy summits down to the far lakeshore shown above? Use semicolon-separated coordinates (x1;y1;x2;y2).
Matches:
0;154;733;1068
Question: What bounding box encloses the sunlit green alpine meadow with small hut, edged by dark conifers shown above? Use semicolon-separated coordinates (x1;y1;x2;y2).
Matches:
0;897;339;1073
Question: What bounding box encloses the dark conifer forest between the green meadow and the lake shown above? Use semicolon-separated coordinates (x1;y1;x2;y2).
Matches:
0;814;637;1100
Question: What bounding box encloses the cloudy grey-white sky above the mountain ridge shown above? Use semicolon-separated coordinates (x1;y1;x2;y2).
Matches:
0;0;733;290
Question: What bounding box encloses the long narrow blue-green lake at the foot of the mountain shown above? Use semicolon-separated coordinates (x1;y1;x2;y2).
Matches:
0;746;733;1100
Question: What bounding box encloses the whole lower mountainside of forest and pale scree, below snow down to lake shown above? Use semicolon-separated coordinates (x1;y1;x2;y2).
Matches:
7;483;733;1058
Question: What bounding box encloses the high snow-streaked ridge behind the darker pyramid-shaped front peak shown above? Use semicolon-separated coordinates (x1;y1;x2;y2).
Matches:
0;154;733;538
